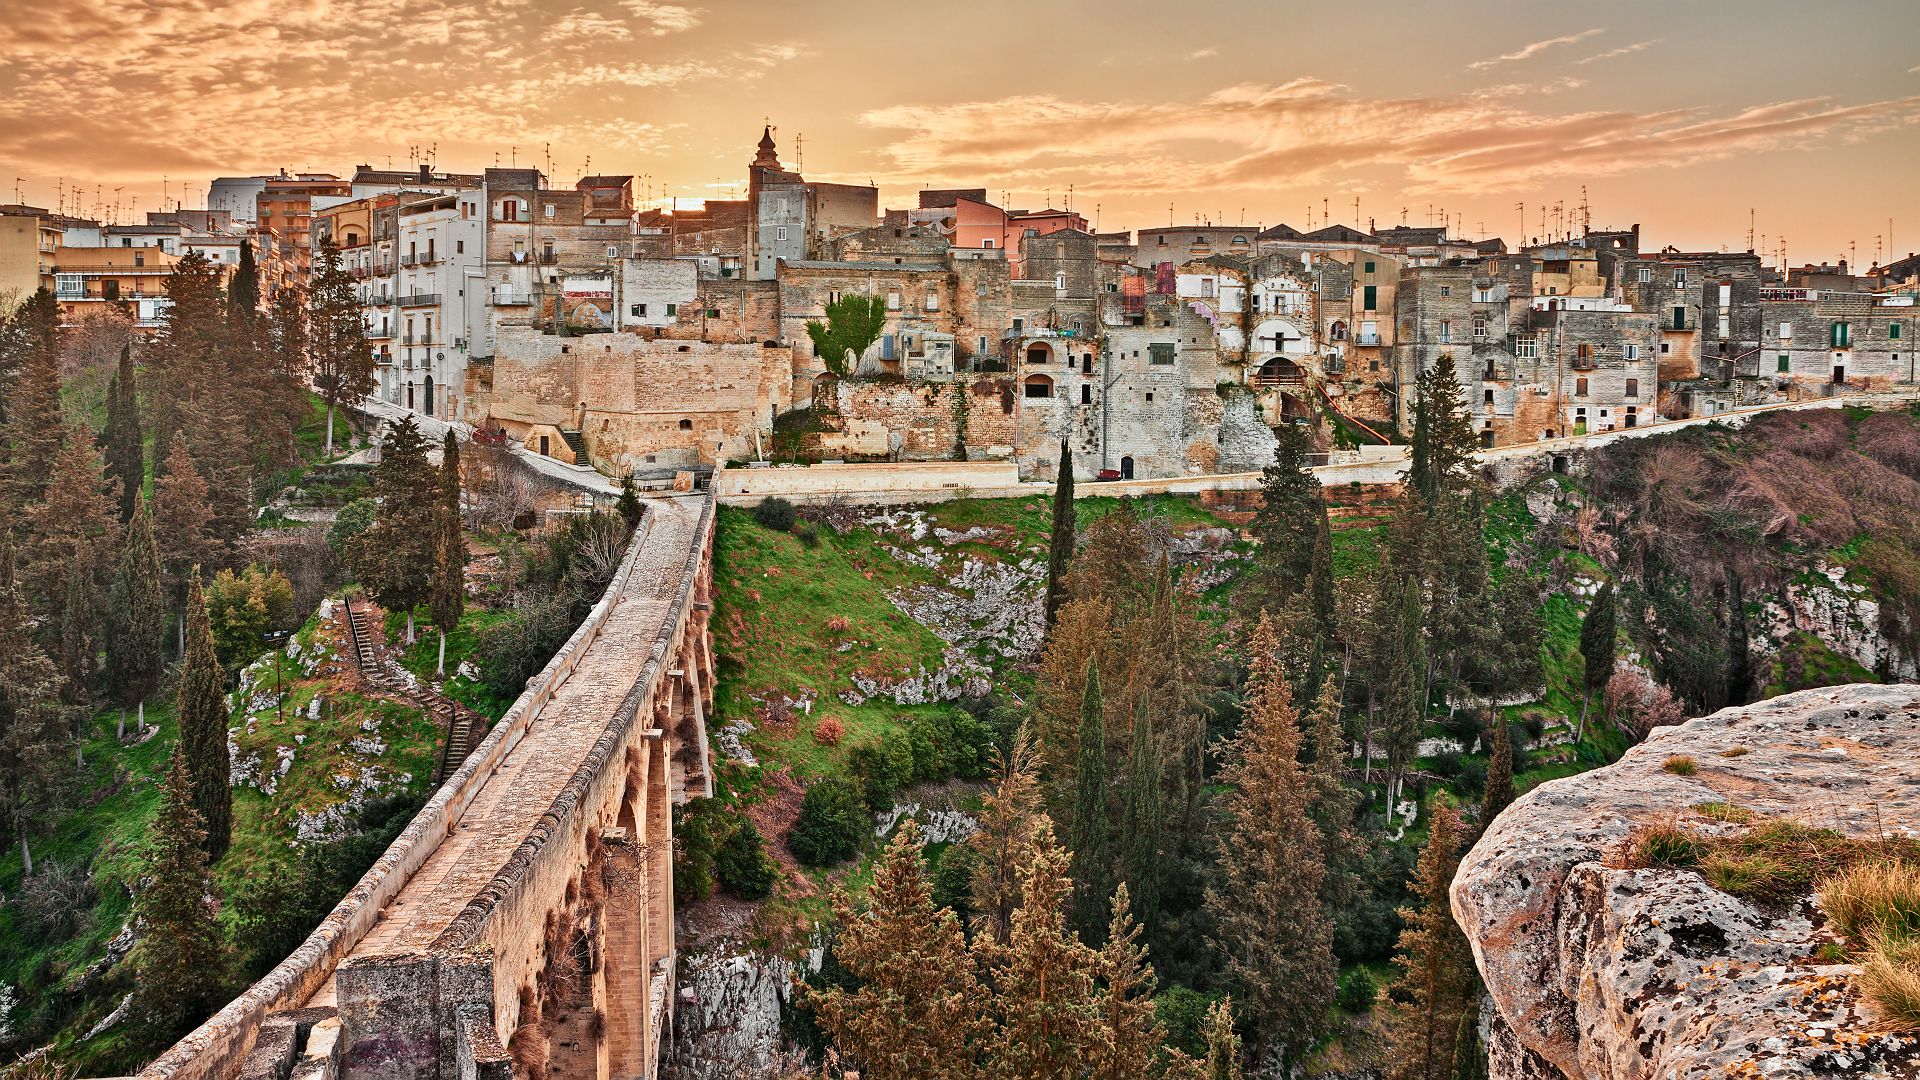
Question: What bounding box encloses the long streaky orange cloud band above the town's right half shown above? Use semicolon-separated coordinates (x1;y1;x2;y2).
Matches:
860;79;1920;194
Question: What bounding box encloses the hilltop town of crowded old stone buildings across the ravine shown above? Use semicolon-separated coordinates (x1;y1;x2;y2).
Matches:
0;131;1920;480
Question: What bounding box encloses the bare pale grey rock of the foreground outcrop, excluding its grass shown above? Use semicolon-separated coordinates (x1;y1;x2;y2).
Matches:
1453;686;1920;1080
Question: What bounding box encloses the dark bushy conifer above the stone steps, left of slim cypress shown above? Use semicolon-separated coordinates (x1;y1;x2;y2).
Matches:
348;415;445;644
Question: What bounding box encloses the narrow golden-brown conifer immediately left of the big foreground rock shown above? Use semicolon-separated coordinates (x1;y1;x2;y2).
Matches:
1382;805;1480;1080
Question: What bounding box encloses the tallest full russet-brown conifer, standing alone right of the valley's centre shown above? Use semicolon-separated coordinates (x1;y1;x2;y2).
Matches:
1206;615;1336;1055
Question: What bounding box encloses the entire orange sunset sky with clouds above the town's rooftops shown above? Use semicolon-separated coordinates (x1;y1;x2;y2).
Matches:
0;0;1920;265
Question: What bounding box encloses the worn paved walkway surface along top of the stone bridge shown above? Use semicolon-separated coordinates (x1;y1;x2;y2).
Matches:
307;498;705;1007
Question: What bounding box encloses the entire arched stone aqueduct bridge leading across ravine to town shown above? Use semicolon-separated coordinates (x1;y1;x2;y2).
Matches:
140;496;714;1080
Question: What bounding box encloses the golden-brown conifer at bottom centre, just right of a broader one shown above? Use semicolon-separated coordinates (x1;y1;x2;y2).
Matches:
973;824;1098;1080
